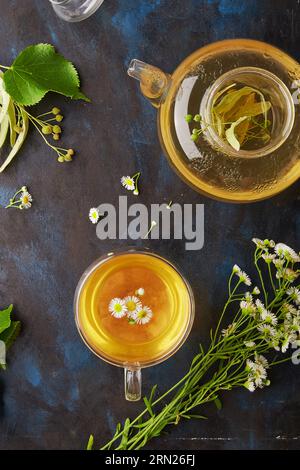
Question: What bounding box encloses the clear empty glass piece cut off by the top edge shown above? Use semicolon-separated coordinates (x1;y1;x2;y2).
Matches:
50;0;104;22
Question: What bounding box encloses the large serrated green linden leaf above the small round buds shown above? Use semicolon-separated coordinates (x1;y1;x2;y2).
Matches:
3;44;89;106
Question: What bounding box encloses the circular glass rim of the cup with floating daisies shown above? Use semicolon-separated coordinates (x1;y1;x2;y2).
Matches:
73;247;195;369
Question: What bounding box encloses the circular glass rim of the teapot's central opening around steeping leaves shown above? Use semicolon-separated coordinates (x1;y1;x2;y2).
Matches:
200;66;295;159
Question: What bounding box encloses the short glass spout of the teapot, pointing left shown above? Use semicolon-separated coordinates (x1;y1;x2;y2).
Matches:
127;59;171;108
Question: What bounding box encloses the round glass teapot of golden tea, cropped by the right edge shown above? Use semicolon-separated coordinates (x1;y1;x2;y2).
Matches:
128;39;300;202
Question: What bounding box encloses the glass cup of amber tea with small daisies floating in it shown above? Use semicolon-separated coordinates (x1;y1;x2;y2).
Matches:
74;249;194;401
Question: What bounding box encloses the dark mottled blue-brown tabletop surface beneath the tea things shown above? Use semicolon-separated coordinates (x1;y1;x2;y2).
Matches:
0;0;300;449
